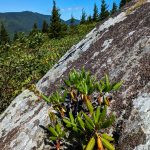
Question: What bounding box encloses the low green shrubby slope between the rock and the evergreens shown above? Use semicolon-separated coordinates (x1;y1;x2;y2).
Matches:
0;23;95;112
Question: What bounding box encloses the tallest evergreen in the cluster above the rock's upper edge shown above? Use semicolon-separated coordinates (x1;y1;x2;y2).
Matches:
100;0;109;20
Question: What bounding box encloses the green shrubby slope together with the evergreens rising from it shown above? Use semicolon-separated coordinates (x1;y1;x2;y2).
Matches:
0;0;131;112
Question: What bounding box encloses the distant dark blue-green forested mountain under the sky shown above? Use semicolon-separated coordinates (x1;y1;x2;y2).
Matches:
0;11;80;35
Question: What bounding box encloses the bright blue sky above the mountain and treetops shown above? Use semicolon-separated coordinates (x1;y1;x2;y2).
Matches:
0;0;120;20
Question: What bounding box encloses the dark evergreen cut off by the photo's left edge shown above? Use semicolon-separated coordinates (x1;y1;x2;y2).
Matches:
0;23;10;44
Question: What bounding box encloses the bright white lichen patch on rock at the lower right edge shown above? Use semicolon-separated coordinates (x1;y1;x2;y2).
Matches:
133;93;150;150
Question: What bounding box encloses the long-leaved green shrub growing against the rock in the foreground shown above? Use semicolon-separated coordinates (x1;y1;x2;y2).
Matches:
35;69;122;150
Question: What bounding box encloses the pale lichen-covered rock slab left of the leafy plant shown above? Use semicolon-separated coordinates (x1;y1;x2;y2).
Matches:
0;90;49;150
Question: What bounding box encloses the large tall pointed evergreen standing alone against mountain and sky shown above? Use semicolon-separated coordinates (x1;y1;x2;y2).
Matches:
50;1;62;38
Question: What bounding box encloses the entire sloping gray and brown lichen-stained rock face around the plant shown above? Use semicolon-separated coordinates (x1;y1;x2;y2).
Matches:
0;1;150;150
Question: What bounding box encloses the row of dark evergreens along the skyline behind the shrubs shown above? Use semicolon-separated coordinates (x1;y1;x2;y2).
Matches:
0;0;131;44
